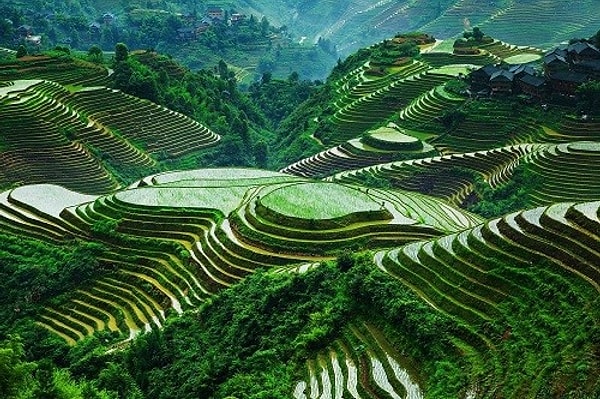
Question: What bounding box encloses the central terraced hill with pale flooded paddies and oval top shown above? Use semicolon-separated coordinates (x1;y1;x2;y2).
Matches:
0;169;480;344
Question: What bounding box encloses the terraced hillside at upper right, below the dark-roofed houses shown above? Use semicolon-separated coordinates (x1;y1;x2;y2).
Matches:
281;32;600;212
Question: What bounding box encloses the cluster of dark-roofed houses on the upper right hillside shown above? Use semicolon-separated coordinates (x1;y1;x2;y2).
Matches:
470;41;600;99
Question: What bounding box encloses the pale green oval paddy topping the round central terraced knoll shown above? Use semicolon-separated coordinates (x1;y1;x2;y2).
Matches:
261;183;381;219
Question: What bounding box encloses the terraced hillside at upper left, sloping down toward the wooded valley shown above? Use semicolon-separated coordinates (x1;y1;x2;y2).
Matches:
0;80;219;194
